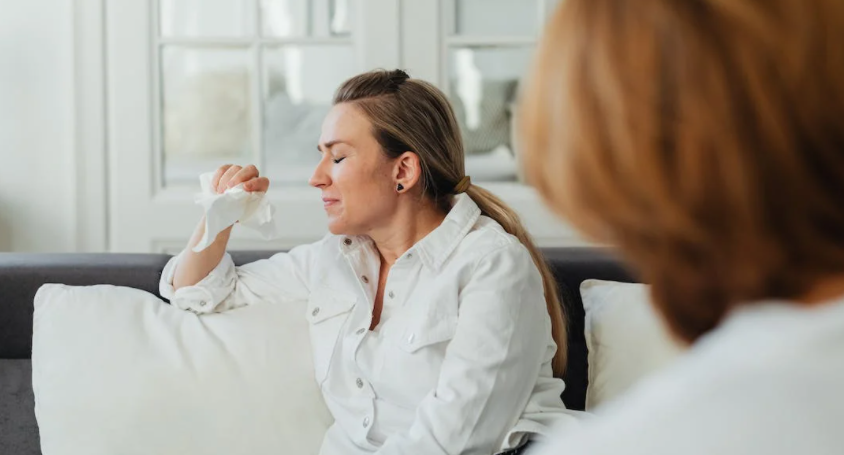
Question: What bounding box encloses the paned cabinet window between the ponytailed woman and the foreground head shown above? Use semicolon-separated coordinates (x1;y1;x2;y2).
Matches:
440;0;556;182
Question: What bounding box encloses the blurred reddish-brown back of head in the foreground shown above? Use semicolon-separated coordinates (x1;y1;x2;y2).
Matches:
521;0;844;341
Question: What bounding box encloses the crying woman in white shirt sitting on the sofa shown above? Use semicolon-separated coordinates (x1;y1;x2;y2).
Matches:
162;71;571;455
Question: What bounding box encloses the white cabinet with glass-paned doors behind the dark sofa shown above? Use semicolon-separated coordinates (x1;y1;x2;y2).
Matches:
105;0;578;252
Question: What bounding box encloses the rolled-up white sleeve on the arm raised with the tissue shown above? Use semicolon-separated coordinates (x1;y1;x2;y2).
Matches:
159;242;321;313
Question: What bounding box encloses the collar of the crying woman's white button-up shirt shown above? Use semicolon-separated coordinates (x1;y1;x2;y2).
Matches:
341;193;481;270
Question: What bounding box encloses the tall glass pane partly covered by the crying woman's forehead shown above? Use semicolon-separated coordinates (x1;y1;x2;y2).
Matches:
263;45;357;184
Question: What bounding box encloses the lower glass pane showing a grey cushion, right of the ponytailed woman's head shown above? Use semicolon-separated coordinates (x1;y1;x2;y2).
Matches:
448;46;533;181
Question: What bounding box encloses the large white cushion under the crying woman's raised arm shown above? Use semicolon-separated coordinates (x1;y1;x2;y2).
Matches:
32;284;332;455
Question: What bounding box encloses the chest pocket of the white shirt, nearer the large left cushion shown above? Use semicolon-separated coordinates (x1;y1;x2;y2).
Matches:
306;287;357;384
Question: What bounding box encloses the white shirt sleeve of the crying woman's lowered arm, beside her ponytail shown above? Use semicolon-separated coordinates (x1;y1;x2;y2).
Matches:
376;244;553;455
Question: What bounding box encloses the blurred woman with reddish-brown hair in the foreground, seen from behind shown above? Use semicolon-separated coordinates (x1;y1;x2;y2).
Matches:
520;0;844;455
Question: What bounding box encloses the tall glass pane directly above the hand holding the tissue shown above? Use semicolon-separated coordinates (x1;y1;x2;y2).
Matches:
161;46;252;182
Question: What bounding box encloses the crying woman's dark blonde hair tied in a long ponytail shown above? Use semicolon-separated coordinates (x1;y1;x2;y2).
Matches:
334;70;567;375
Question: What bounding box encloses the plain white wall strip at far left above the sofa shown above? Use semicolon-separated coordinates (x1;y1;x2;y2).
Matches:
0;0;76;252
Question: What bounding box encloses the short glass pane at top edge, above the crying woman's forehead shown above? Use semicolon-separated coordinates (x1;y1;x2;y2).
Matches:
261;0;355;37
